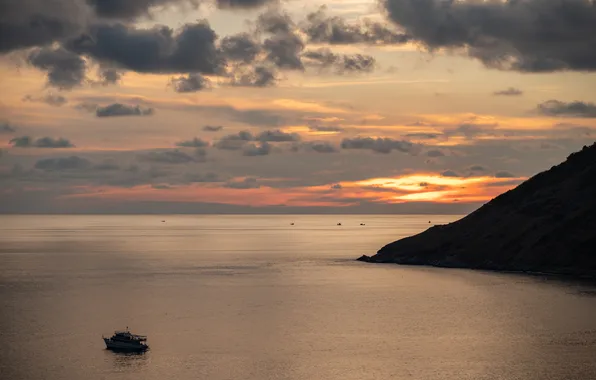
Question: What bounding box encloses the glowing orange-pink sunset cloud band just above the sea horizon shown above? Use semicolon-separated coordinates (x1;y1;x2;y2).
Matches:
64;174;525;207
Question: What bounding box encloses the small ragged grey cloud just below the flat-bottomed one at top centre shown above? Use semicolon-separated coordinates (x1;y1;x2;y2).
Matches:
302;48;376;74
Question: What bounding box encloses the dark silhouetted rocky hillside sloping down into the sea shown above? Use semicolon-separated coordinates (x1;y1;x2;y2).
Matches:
359;143;596;277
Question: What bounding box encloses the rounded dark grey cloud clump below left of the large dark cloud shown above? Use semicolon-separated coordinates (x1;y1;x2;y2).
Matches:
27;47;87;90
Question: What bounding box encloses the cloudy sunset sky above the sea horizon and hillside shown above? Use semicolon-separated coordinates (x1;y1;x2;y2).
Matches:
0;0;596;214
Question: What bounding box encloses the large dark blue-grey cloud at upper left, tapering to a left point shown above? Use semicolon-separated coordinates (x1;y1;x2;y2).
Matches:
66;21;224;74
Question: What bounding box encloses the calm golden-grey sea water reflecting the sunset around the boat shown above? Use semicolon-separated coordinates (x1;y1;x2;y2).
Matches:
0;216;596;380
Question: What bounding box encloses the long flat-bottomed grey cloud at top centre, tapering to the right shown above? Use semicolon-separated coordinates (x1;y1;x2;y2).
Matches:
301;6;409;44
